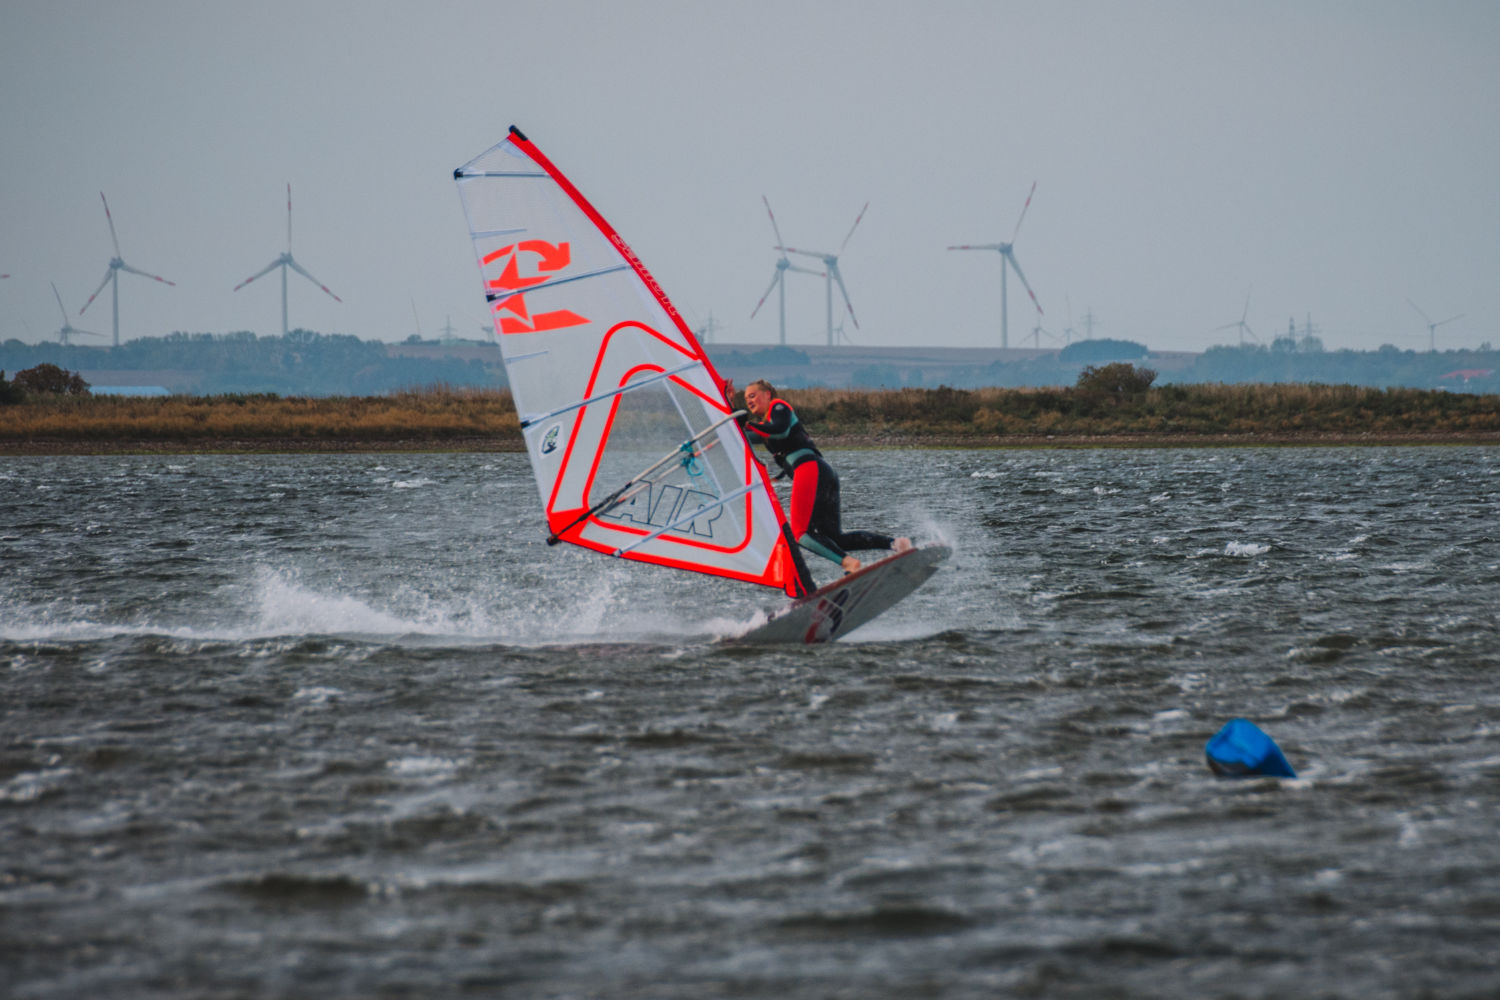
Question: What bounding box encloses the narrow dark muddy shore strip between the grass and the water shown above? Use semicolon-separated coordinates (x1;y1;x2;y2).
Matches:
0;432;1500;457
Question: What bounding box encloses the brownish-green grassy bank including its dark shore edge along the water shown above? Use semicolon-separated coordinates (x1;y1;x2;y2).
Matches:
0;385;1500;454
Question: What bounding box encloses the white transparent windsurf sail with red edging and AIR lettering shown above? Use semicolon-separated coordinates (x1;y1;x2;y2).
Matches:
453;127;804;597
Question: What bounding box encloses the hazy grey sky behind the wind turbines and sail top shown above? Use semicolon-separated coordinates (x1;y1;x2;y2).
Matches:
0;0;1500;349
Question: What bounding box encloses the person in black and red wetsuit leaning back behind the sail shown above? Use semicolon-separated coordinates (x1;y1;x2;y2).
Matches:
725;379;912;573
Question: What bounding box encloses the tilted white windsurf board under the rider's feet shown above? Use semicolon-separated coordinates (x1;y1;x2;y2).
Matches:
728;546;953;645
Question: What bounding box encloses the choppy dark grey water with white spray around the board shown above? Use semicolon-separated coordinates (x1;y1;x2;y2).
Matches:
0;448;1500;1000
